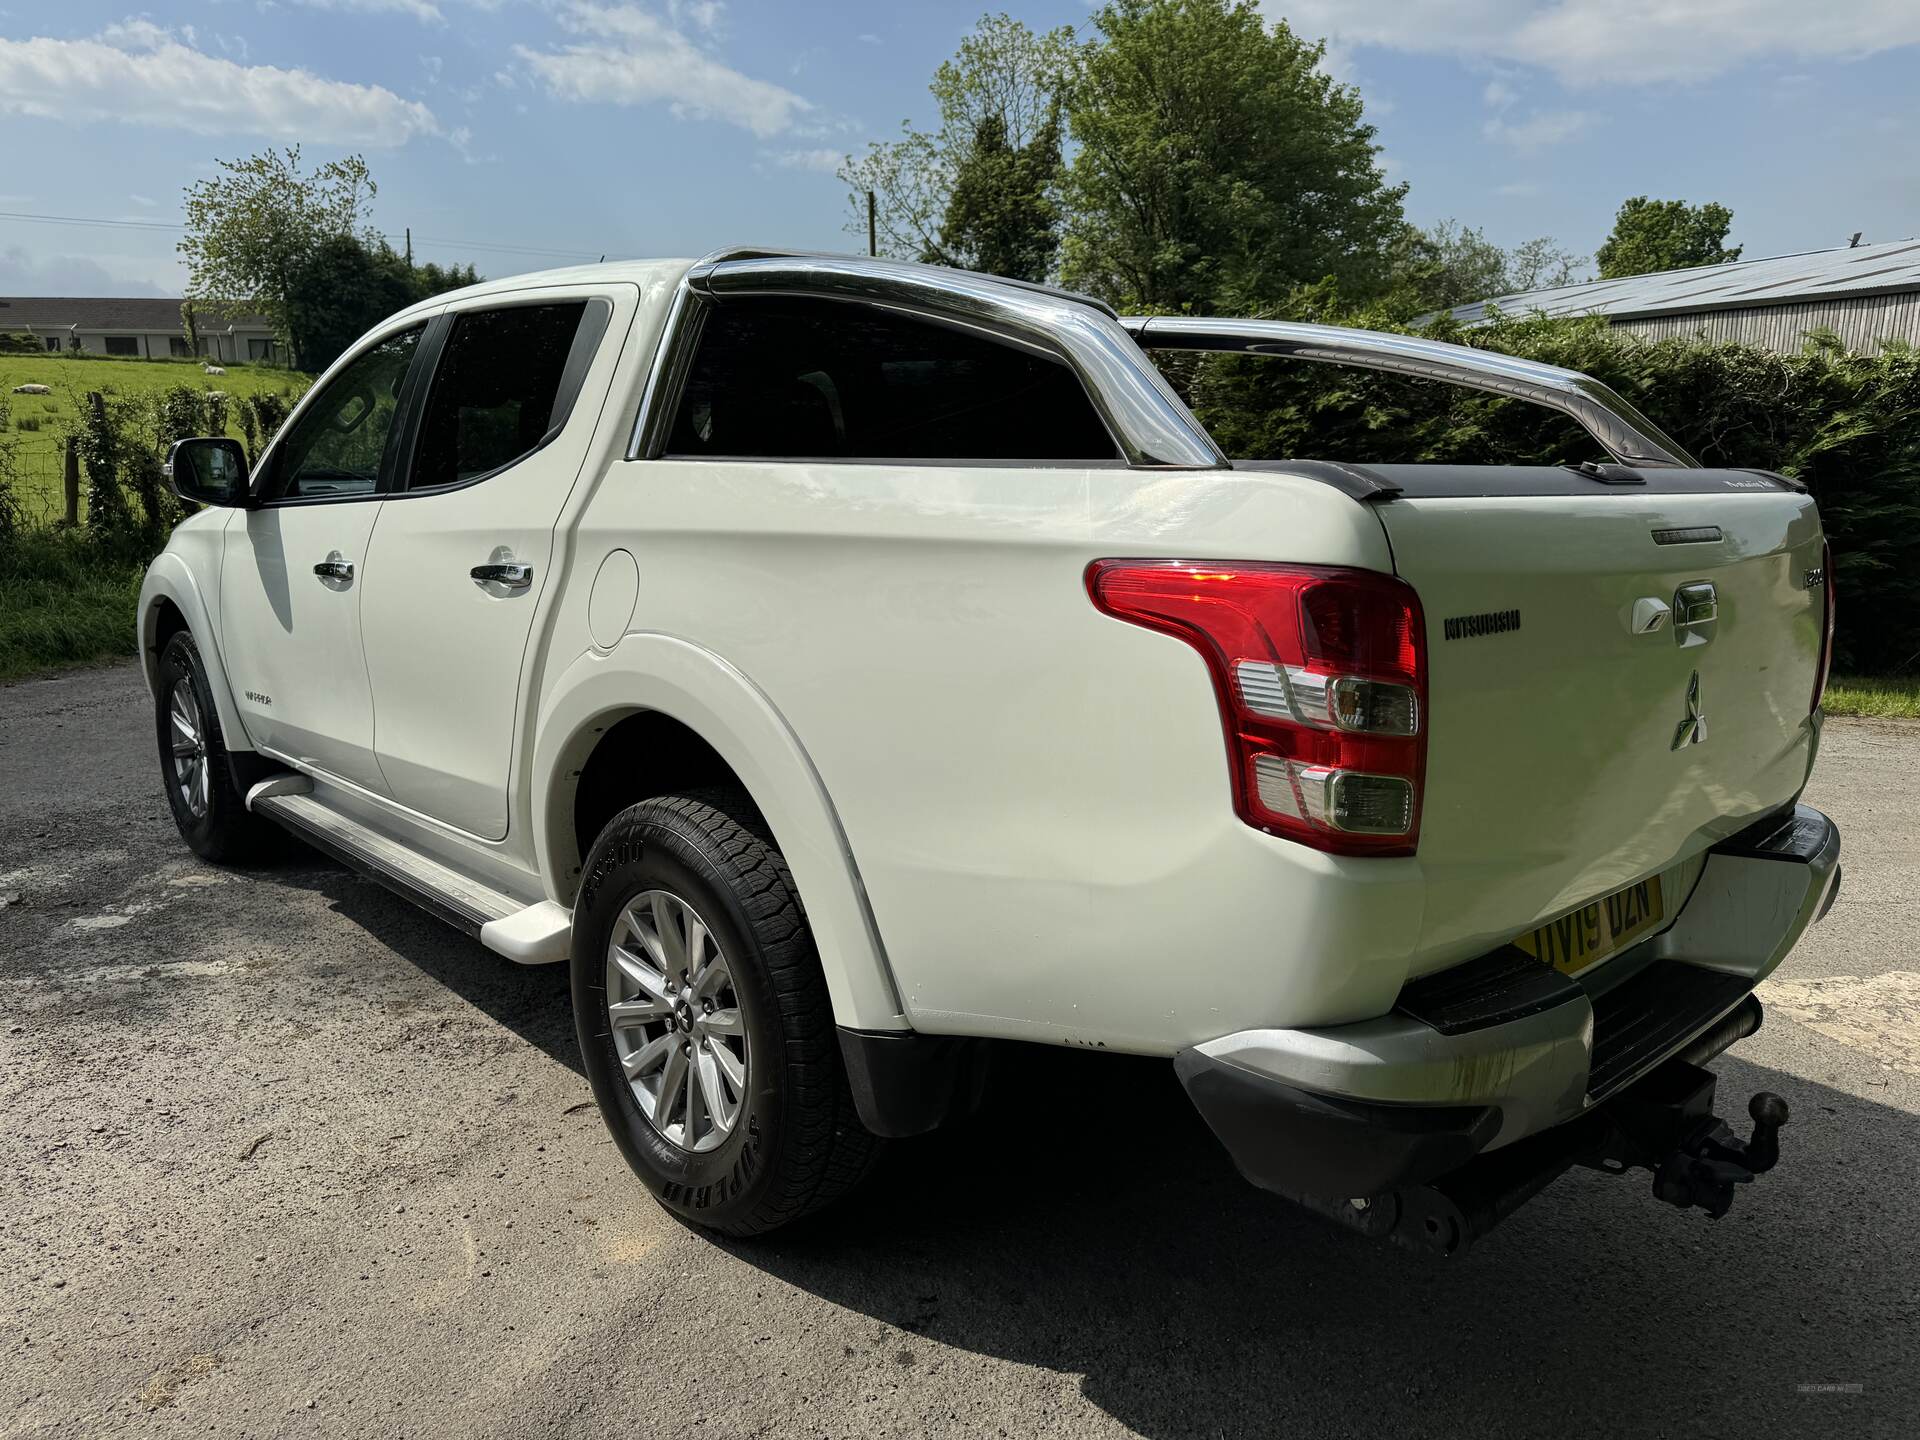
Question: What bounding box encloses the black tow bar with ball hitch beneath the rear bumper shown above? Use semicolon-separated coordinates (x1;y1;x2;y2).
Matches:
1300;1060;1788;1256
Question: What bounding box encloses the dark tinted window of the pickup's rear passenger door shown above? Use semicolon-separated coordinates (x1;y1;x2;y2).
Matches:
407;300;588;490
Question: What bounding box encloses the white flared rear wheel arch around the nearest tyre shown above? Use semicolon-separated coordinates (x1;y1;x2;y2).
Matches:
532;634;906;1029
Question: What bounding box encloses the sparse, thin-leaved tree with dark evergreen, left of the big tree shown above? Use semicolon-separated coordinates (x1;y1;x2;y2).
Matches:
839;15;1073;280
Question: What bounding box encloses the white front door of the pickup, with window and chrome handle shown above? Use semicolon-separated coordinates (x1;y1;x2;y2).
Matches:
219;324;426;793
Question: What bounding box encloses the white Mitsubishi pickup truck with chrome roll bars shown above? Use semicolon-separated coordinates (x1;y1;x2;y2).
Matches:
138;252;1839;1250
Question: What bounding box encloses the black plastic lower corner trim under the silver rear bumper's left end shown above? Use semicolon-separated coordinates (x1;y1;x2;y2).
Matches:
1173;1050;1500;1196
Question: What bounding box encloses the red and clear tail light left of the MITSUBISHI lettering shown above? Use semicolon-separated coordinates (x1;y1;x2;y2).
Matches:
1087;561;1427;854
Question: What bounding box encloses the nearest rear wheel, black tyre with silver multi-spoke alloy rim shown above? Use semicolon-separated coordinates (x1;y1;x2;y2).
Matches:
572;795;881;1235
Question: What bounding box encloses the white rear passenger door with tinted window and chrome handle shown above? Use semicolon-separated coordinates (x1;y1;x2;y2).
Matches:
361;286;622;839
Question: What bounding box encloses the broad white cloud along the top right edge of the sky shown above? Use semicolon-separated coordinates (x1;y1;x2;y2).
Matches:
1265;0;1920;86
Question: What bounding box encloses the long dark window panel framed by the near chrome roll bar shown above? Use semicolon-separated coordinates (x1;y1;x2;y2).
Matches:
666;300;1119;461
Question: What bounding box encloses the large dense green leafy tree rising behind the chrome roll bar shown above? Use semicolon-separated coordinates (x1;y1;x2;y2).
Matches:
1064;0;1405;313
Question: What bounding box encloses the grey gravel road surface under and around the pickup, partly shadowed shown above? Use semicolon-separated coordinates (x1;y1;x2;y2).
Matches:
0;666;1920;1440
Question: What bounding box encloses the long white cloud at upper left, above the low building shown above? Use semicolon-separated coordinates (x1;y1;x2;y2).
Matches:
0;21;440;148
